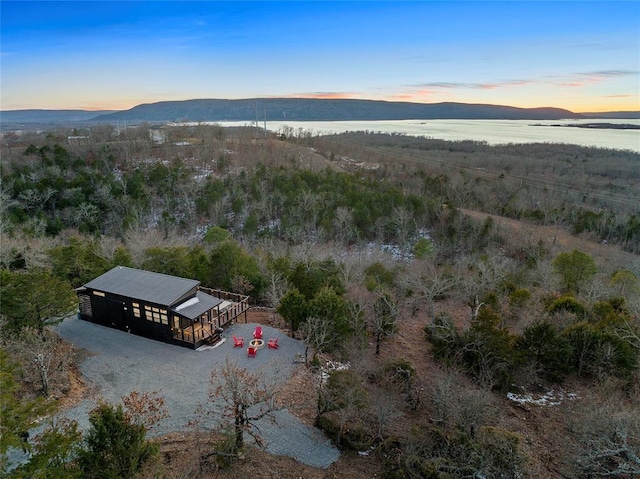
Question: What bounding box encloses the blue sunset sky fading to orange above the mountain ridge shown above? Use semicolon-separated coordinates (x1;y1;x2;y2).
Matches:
0;0;640;112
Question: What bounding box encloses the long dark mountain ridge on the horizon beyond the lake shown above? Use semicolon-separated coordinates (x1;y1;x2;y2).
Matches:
0;98;640;125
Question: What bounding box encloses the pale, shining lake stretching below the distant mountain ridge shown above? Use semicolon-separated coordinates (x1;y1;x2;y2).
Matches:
218;119;640;152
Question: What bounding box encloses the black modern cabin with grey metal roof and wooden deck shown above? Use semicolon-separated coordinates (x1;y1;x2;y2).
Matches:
76;266;249;349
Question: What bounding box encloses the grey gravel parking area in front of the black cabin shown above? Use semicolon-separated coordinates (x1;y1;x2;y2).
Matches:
57;317;339;468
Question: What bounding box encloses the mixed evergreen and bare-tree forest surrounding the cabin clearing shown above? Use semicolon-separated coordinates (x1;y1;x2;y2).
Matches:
0;124;640;479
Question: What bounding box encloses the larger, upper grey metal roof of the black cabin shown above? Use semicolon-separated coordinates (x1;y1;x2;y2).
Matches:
85;266;199;307
